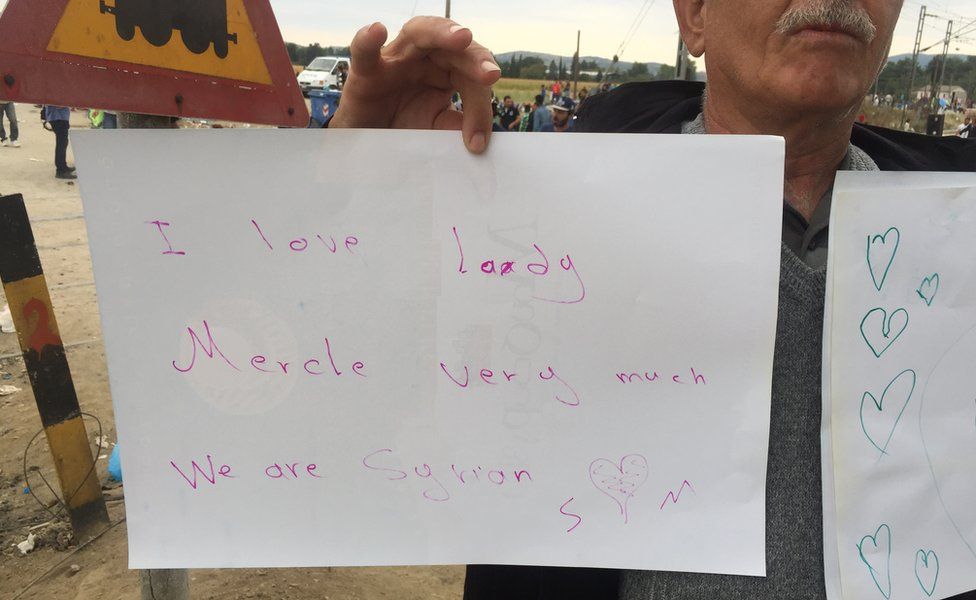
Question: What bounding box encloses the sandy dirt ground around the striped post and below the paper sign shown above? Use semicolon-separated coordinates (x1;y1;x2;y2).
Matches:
0;104;464;600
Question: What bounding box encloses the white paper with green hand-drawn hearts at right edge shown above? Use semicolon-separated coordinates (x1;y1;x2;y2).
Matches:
824;173;976;600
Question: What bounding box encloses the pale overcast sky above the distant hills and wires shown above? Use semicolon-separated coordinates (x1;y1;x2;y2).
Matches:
270;0;976;63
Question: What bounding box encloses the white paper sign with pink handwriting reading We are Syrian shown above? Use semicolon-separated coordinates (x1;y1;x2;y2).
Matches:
73;130;783;575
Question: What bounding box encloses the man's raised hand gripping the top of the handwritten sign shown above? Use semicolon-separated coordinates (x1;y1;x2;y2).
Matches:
329;17;501;153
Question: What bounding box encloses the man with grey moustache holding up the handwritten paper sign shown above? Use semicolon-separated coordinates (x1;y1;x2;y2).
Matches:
330;0;976;600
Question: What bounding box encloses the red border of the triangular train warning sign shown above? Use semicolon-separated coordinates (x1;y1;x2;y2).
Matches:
0;0;309;127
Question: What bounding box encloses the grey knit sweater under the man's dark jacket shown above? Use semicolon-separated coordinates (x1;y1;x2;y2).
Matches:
620;116;878;600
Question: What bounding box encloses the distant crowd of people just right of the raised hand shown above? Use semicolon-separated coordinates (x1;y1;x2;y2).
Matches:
488;81;612;132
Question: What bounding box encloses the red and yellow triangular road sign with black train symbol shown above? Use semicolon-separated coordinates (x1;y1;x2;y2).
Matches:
0;0;308;127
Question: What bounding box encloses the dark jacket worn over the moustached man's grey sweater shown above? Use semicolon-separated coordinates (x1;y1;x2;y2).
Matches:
464;81;976;600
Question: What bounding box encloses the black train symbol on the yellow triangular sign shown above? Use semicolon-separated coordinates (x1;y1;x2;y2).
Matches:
98;0;237;58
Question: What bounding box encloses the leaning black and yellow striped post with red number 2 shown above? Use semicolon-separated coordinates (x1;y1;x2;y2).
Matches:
0;194;109;542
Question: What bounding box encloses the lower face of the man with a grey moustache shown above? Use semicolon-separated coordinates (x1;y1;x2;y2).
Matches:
702;0;903;112
